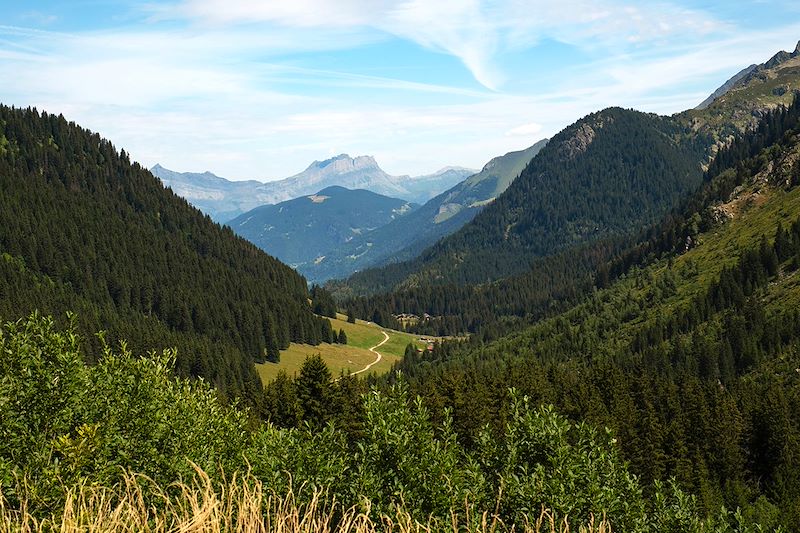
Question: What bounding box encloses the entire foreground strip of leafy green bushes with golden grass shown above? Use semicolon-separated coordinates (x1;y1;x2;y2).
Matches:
0;316;780;532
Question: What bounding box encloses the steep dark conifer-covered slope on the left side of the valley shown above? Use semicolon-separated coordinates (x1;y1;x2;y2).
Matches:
0;106;331;404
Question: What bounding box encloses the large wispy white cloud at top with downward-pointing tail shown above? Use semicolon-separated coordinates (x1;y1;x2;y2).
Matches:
167;0;725;90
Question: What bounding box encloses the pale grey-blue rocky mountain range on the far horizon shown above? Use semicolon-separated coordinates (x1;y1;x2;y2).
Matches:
150;154;475;223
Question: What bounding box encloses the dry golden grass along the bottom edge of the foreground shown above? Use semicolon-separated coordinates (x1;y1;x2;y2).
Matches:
0;469;611;533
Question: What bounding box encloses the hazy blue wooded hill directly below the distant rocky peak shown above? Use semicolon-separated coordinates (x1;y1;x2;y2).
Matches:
227;186;418;270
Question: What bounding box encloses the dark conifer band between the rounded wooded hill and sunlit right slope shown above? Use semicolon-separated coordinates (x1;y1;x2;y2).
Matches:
345;96;797;339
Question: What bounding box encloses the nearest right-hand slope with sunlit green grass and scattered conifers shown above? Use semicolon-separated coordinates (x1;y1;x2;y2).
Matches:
390;96;800;530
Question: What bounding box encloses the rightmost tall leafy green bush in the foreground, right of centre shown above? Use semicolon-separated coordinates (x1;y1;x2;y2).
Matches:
479;390;645;531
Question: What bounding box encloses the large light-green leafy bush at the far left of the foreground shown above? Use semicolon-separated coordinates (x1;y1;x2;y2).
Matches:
0;315;251;507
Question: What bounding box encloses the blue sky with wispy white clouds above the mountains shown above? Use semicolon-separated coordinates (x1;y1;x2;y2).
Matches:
0;0;800;181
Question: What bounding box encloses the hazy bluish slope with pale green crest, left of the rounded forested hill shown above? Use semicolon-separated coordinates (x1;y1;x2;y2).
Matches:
300;140;547;282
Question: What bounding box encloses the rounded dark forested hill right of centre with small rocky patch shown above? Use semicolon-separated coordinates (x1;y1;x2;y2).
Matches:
338;108;707;294
